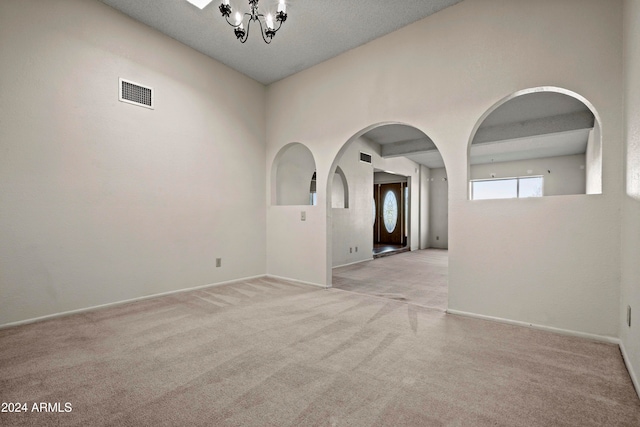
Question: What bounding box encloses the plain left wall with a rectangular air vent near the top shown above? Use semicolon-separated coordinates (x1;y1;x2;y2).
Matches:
0;0;266;325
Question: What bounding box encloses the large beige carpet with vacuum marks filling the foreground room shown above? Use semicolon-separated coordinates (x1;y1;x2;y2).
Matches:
0;279;640;427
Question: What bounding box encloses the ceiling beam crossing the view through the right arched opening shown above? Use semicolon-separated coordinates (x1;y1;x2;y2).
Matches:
472;111;594;144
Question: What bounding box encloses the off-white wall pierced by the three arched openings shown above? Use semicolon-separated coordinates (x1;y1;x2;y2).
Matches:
267;0;622;337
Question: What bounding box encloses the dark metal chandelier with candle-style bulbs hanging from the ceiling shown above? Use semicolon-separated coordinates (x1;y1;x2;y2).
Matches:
220;0;287;44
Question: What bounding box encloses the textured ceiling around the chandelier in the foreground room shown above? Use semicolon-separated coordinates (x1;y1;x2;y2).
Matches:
96;0;462;84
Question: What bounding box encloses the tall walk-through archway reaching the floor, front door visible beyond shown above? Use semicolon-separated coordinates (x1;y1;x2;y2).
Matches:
327;123;448;310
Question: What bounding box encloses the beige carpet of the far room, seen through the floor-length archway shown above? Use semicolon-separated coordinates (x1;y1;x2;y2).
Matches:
332;249;449;311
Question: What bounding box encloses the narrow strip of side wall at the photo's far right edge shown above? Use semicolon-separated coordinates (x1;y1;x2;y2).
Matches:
619;0;640;394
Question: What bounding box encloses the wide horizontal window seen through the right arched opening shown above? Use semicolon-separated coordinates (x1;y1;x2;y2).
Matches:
471;176;544;200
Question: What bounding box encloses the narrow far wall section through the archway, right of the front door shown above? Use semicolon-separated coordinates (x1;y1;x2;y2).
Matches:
429;168;449;249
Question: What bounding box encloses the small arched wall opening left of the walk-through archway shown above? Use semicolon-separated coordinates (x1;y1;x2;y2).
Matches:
271;142;316;206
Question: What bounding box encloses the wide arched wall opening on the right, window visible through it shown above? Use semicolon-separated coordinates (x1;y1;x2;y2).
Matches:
468;87;602;200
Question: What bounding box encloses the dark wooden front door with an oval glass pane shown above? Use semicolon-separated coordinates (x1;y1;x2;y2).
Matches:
373;183;405;245
